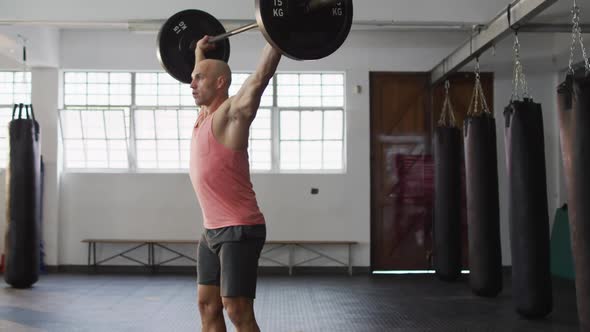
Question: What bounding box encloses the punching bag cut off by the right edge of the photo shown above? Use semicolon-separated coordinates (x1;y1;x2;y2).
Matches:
557;74;590;331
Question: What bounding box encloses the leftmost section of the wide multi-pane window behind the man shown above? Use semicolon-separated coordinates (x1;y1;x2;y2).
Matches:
59;72;132;169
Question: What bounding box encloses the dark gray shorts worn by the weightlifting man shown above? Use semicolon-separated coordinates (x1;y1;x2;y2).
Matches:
197;225;266;299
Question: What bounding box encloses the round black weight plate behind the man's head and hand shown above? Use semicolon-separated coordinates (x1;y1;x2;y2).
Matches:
157;9;229;83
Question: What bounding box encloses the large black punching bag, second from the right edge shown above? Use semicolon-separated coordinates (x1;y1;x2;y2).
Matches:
504;98;553;318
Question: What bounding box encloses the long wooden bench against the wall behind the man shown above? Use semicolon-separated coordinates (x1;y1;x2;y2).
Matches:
82;239;358;275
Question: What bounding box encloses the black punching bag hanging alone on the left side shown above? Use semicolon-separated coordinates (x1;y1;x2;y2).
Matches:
4;104;41;288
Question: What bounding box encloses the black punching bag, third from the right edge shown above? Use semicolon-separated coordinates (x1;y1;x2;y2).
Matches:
464;113;502;297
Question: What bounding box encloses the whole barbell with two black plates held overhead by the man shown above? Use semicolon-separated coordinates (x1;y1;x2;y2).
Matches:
157;0;352;83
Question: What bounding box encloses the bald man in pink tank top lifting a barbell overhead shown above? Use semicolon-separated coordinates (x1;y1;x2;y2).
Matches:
190;36;281;331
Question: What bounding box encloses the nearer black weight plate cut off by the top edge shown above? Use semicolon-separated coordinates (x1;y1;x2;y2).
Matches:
256;0;353;60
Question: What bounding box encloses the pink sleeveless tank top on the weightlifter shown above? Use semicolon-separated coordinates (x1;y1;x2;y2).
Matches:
189;114;264;229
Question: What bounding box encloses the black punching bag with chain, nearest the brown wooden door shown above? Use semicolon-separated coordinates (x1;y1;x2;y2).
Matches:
433;81;462;281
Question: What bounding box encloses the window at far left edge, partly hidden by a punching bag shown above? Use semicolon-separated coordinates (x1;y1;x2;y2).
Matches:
0;71;31;168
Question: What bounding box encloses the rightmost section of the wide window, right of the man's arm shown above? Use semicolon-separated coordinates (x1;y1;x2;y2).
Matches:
277;74;345;171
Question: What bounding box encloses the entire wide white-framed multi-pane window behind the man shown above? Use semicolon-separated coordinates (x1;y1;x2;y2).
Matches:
60;72;345;172
